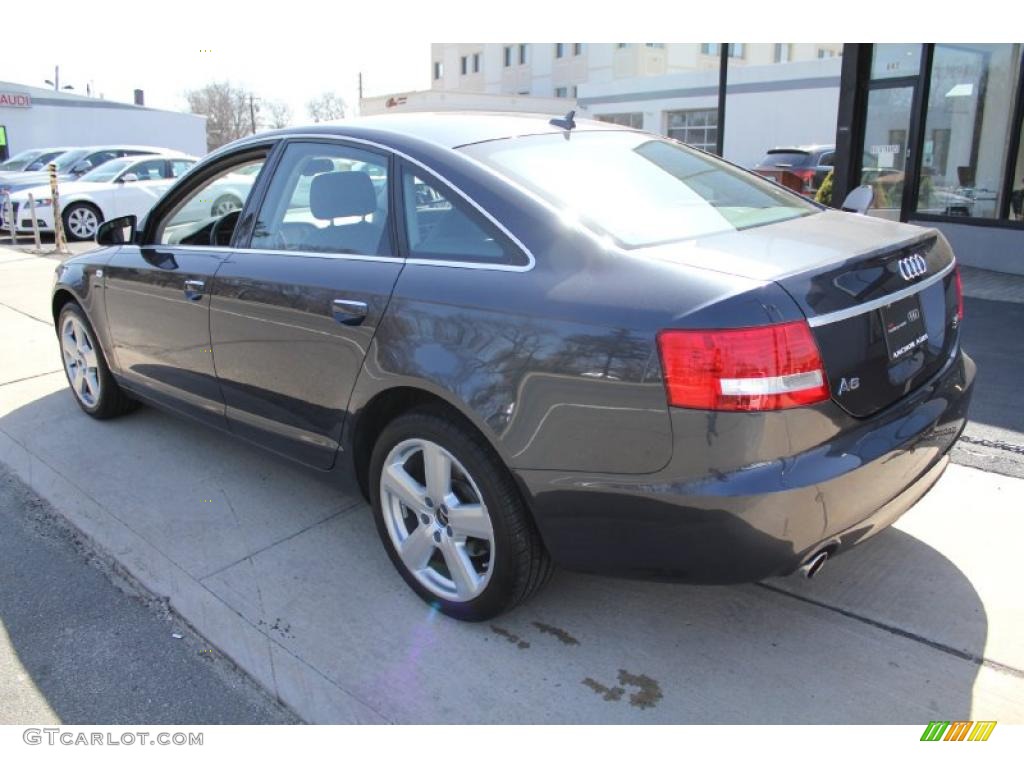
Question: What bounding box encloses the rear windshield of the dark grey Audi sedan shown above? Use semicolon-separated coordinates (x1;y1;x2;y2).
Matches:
461;131;819;248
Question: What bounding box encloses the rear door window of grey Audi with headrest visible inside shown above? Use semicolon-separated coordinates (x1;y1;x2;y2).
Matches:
251;142;392;256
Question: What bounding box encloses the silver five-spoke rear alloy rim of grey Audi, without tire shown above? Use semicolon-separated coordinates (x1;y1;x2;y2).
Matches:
380;439;495;602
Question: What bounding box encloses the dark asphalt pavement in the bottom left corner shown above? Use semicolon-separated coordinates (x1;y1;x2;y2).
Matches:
0;466;297;725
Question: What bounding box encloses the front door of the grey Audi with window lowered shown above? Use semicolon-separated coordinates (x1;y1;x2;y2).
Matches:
104;151;263;426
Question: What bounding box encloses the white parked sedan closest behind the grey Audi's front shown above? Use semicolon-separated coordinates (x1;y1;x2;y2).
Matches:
3;155;197;240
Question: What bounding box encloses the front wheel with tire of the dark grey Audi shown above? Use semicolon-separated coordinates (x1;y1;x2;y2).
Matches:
57;301;138;419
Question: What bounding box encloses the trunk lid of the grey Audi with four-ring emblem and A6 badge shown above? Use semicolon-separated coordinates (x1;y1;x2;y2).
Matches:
638;212;959;417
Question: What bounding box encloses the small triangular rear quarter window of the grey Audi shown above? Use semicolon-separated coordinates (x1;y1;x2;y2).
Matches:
401;165;525;264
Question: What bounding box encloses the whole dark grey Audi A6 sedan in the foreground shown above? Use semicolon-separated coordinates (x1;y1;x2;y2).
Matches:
53;114;975;621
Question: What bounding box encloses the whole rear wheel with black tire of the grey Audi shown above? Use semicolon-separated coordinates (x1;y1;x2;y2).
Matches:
370;409;552;622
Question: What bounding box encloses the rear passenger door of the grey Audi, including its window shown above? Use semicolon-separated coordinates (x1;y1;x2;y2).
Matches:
210;140;403;469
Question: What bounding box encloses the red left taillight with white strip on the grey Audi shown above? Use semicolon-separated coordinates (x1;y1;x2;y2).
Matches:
657;321;828;411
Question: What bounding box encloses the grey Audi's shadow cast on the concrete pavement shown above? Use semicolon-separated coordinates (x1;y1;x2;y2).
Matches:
0;389;987;725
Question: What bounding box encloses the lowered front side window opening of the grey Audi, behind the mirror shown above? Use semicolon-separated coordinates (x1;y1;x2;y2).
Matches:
155;158;266;245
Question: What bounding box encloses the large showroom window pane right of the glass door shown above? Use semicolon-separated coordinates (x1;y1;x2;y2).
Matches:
918;43;1024;219
